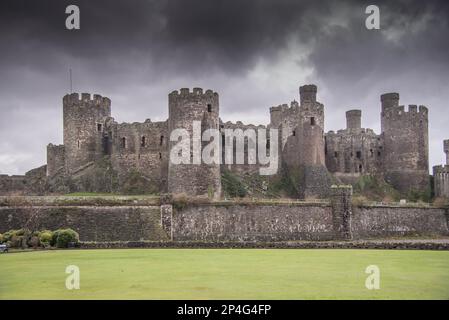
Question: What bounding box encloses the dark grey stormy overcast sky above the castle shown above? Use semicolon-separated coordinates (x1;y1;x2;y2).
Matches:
0;0;449;174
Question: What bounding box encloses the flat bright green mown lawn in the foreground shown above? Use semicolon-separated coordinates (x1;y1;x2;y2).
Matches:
0;249;449;299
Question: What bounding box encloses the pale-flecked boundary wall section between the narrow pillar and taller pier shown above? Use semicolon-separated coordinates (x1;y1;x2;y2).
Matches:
172;204;334;241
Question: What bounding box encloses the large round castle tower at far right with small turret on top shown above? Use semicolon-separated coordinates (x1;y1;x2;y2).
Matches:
381;93;429;194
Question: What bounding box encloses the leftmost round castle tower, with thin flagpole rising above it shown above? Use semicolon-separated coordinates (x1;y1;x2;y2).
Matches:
63;93;111;174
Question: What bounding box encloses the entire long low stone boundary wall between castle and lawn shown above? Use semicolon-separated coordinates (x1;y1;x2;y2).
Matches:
0;186;449;243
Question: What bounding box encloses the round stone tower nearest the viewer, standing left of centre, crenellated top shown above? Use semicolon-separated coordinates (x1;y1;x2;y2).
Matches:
168;88;221;198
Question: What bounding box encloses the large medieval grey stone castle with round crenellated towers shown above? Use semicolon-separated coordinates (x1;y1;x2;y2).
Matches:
0;85;440;198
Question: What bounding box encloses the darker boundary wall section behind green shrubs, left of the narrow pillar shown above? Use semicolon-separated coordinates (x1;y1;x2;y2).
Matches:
0;206;168;242
